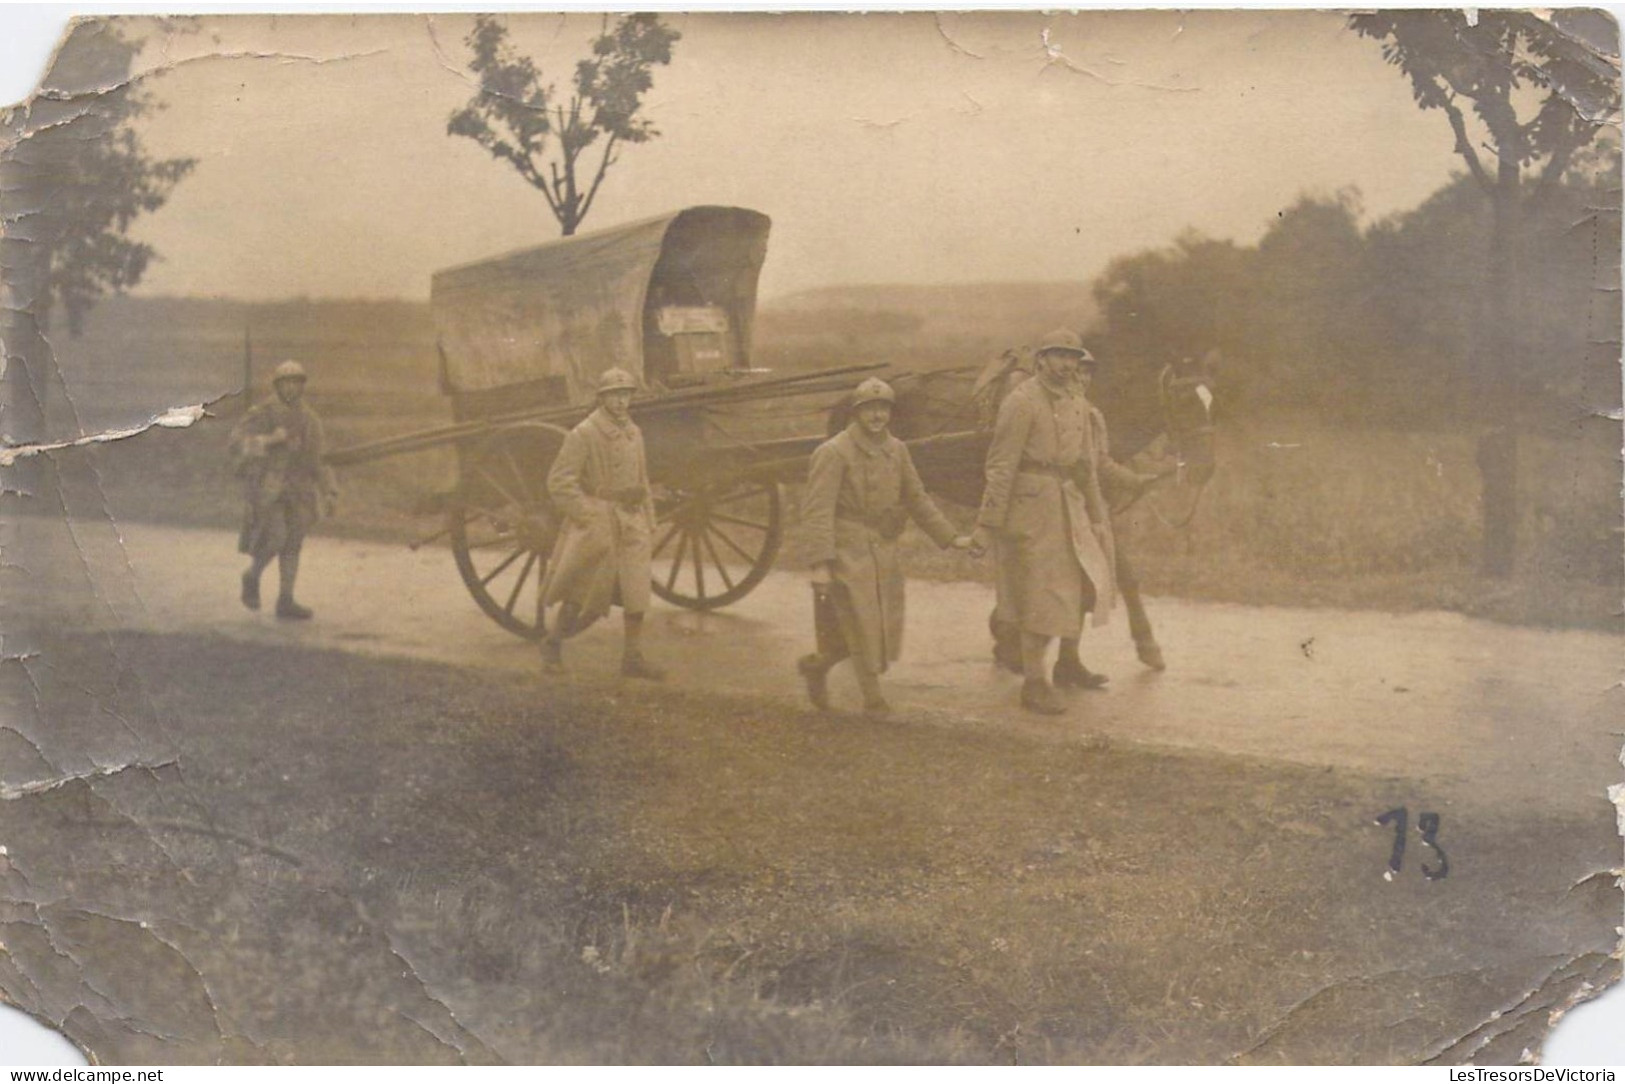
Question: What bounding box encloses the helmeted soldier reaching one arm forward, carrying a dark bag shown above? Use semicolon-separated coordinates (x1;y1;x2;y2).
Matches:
796;377;970;717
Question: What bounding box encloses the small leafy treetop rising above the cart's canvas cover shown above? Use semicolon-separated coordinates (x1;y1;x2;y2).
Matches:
445;15;681;237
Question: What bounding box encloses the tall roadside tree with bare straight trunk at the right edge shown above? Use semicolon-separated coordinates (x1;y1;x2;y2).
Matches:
1349;10;1620;575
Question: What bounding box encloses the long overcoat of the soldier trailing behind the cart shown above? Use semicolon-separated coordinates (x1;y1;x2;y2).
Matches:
231;400;338;556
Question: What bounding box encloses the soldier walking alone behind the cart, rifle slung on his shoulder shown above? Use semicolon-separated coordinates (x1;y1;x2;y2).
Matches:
231;361;338;621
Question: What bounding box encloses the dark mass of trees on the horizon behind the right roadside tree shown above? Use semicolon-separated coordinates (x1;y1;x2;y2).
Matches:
1089;160;1620;426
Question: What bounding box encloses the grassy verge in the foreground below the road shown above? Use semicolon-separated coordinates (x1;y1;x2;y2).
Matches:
0;634;1619;1064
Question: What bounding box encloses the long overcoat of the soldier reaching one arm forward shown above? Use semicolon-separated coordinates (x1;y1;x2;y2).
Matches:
801;421;956;673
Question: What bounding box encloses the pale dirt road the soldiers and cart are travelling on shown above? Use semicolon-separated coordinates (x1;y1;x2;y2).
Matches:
23;520;1620;809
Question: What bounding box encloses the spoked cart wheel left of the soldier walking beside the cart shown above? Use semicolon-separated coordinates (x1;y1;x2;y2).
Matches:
449;423;564;640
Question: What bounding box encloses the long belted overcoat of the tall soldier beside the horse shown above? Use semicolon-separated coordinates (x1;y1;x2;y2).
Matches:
977;379;1116;639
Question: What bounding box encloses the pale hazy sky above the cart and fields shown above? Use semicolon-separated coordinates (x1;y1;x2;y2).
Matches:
19;11;1454;299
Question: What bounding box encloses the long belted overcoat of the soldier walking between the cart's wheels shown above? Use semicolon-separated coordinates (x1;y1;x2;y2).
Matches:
541;408;655;629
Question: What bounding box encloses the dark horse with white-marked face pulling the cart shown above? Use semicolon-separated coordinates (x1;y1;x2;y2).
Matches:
829;346;1219;672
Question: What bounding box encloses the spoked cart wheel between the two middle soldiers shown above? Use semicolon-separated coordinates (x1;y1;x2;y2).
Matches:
653;481;783;609
